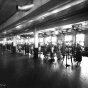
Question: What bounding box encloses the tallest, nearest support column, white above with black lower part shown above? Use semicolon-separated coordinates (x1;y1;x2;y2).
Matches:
34;28;38;59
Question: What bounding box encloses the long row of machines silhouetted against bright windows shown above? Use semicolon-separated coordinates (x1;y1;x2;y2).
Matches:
0;24;84;67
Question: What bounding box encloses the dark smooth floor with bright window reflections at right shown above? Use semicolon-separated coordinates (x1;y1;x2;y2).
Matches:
0;50;88;88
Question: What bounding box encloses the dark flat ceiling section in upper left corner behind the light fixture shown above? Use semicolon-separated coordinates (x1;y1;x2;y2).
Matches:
0;0;33;25
